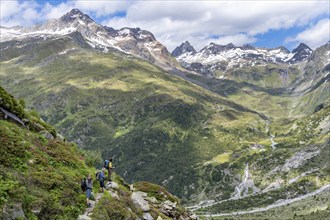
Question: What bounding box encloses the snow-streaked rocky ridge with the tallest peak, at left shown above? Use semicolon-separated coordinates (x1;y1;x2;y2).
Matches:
0;9;176;67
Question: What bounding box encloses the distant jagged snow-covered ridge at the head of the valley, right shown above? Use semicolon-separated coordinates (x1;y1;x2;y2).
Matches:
172;42;313;77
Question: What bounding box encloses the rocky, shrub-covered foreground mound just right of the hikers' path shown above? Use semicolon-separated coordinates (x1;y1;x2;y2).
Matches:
77;180;198;220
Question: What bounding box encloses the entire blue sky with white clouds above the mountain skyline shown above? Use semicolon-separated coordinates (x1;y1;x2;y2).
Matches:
0;0;330;51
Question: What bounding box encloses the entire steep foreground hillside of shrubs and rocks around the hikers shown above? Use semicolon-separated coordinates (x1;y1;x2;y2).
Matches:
0;87;196;220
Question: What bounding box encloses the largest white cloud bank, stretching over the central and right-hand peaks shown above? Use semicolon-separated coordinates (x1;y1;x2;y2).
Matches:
103;1;329;50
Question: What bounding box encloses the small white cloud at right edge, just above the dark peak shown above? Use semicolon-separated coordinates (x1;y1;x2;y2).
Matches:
286;19;330;49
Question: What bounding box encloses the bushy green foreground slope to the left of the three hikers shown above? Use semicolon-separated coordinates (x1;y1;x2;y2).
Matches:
0;87;94;219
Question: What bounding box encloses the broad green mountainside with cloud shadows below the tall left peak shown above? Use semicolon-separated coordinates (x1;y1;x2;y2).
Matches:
1;34;266;201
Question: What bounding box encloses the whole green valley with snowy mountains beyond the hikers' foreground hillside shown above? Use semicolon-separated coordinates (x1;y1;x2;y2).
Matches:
0;7;330;219
